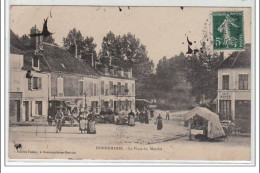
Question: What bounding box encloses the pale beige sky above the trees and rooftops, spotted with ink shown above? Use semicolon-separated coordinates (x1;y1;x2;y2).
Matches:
10;6;251;64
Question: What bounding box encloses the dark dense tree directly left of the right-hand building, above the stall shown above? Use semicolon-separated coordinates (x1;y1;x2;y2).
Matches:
186;42;223;103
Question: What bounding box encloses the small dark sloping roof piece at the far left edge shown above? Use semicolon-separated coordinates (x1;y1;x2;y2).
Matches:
10;30;28;53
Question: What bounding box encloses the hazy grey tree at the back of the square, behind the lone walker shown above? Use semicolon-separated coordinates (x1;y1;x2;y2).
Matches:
150;53;192;109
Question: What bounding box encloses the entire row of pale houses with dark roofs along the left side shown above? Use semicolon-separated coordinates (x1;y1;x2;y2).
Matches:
10;27;135;122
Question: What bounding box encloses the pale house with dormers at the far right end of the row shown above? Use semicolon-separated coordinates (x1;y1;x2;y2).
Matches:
95;59;135;112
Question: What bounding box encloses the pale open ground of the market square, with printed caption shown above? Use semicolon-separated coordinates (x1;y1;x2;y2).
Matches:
9;111;250;160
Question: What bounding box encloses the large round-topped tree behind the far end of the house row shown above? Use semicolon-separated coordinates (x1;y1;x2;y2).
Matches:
99;31;154;98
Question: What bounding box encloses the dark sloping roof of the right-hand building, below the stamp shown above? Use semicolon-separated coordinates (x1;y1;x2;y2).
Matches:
218;44;251;69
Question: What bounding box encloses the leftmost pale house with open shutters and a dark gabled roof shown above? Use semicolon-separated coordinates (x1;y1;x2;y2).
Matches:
9;31;49;122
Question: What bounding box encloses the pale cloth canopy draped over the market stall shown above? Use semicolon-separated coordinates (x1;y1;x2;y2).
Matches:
184;107;225;138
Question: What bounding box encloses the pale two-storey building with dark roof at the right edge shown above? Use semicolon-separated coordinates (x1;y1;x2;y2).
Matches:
217;44;251;131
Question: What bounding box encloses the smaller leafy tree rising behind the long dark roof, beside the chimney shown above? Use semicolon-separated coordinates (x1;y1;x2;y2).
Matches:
63;28;97;62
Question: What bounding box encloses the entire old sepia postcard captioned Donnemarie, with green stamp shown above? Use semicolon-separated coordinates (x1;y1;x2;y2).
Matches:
6;5;255;163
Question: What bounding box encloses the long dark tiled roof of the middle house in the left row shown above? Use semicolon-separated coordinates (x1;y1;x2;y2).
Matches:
42;43;99;77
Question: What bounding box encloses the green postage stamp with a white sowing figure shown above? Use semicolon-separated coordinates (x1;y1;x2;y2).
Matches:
212;11;244;50
